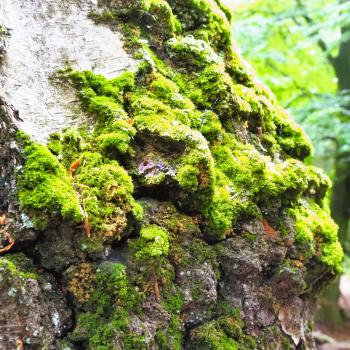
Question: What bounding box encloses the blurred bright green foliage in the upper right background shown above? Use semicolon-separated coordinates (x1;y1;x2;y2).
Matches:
234;0;350;170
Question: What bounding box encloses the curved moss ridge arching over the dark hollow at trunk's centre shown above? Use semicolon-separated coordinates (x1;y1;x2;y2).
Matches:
130;70;217;197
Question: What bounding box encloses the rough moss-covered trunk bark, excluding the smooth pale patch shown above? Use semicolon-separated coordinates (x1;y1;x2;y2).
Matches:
0;0;342;350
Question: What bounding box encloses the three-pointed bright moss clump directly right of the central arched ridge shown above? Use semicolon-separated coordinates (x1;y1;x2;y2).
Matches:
203;134;318;238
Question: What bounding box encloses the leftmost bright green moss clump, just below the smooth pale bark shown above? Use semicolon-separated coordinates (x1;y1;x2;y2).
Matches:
18;137;82;229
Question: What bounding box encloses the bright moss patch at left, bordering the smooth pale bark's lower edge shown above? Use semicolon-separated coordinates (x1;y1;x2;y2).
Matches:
19;72;142;240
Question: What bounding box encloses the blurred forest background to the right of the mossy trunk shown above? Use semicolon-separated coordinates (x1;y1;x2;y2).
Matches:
230;0;350;337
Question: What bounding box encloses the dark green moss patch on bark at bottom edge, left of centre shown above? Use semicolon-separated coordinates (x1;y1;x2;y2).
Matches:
71;262;147;350
